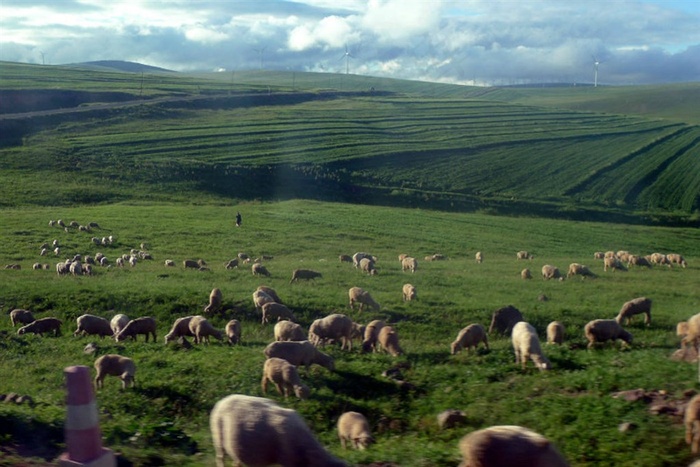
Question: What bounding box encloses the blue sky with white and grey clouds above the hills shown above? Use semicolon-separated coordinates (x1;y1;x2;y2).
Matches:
0;0;700;86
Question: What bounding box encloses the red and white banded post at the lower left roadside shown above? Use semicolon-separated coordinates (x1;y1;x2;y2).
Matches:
59;366;117;467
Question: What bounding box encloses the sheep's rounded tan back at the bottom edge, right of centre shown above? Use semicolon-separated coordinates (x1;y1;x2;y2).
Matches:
459;425;569;467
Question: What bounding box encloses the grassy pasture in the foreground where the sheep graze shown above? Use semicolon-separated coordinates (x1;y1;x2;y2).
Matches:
0;200;700;467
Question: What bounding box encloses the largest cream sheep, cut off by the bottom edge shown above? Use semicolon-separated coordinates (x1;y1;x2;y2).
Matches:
209;394;346;467
